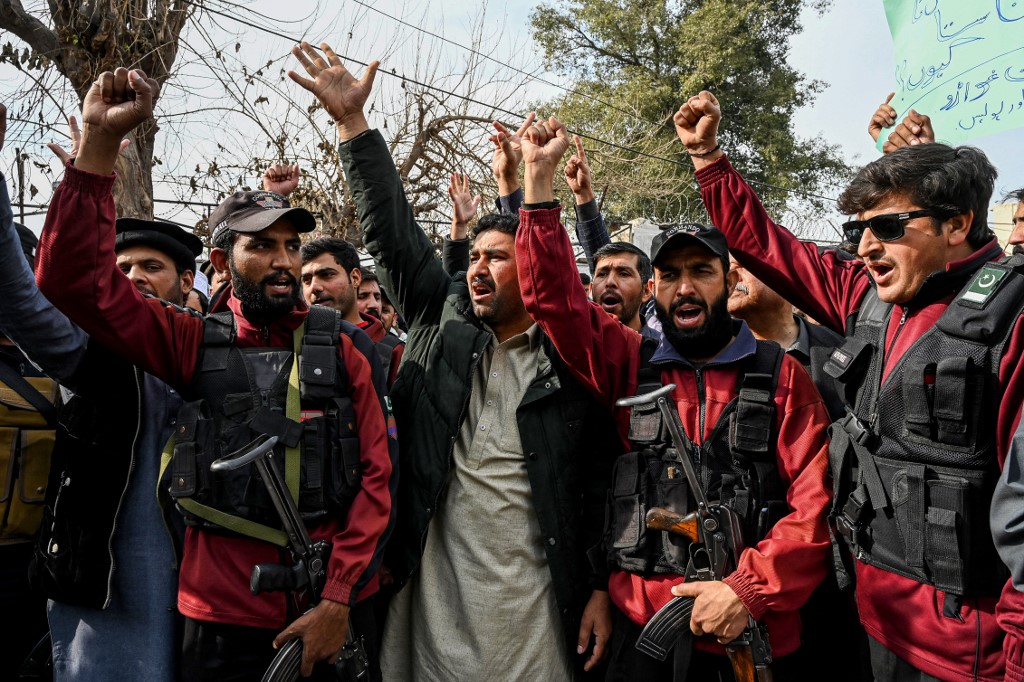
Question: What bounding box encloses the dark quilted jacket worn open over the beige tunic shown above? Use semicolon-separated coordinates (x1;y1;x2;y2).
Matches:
340;131;622;651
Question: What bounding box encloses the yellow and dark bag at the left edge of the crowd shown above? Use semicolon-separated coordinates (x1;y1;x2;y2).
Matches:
0;377;57;545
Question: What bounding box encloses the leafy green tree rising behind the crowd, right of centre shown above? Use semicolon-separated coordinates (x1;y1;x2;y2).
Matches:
530;0;850;222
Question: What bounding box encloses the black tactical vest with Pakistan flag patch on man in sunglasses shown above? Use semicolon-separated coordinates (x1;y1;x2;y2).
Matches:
825;263;1024;596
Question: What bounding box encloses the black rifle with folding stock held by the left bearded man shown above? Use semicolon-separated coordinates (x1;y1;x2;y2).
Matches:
210;435;370;682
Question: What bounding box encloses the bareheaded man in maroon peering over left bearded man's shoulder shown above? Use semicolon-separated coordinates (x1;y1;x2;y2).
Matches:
302;237;406;387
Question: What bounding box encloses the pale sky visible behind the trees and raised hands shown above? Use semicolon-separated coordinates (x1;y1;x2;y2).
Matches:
0;0;1024;231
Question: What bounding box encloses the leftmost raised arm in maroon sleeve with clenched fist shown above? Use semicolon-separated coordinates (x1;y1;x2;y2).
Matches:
37;69;203;388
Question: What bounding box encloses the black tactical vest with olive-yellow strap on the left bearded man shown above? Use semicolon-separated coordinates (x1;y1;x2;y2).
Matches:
170;305;360;539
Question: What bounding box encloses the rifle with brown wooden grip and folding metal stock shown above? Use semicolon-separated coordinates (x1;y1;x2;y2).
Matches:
615;384;772;682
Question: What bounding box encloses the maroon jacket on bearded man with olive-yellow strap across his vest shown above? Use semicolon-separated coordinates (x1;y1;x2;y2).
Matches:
37;164;391;629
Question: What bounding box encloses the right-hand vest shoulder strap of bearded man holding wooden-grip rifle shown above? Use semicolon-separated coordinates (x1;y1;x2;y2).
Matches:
729;341;785;456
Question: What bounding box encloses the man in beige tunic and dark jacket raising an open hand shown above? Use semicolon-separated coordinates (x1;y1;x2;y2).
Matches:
289;43;615;682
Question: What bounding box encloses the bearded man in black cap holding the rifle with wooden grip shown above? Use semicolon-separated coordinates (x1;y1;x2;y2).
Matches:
516;118;829;680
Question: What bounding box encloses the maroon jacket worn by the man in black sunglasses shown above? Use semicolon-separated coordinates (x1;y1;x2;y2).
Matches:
696;153;1024;682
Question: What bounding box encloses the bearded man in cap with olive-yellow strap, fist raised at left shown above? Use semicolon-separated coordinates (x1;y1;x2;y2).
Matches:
33;69;392;680
